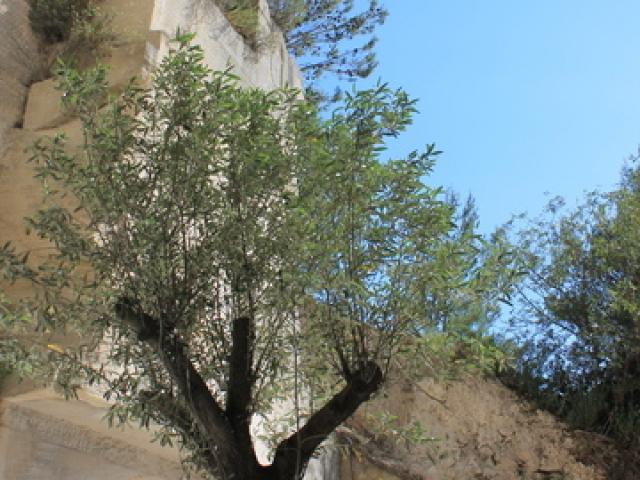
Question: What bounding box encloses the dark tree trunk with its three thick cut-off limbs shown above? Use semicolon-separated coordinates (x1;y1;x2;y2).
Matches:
116;299;383;480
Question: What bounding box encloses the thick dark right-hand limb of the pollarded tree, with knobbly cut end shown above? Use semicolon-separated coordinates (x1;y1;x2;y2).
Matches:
272;361;383;479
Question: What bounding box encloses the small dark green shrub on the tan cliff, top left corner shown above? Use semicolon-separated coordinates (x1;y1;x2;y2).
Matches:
27;0;90;43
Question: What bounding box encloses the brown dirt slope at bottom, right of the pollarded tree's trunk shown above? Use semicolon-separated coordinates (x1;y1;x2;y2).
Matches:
341;376;616;480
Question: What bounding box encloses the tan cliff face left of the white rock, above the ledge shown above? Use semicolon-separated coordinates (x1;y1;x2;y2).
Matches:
0;0;155;297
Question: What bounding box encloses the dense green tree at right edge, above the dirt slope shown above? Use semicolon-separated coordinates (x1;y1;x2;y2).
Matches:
514;162;640;445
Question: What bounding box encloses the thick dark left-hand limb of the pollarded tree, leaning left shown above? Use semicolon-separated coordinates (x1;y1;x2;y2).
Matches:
116;298;245;477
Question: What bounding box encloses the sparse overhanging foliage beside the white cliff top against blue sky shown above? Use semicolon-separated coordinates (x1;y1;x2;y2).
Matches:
267;0;387;80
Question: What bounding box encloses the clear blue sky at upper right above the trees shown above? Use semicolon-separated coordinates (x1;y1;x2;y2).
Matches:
328;0;640;232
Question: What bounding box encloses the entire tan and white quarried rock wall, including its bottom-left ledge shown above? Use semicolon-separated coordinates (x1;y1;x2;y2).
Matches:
0;0;312;480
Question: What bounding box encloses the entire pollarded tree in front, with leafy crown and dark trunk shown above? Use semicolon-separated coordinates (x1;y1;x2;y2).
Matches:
0;37;500;480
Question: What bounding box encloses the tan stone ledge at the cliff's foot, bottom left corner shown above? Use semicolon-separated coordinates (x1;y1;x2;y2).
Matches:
0;390;185;480
